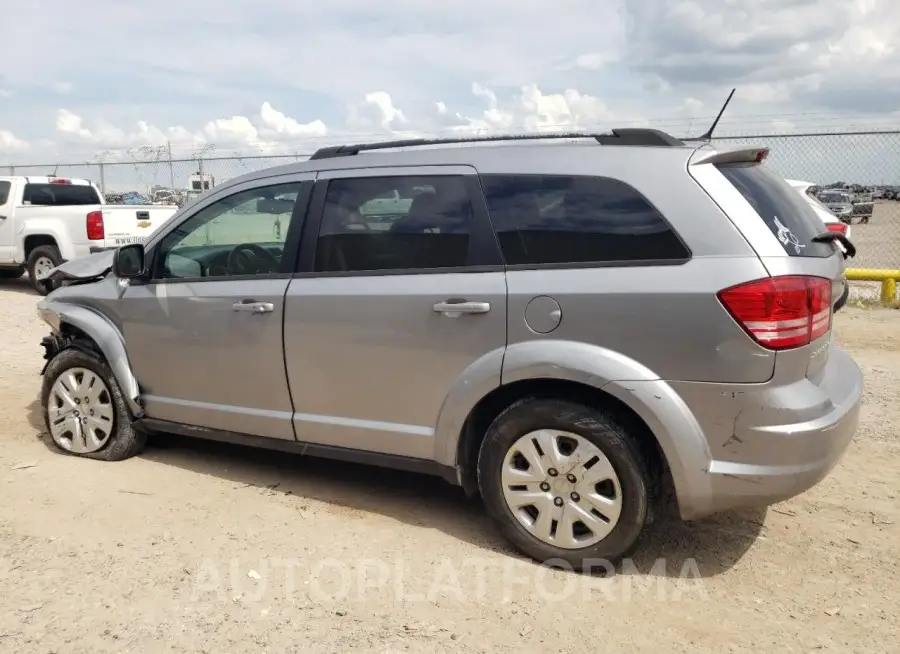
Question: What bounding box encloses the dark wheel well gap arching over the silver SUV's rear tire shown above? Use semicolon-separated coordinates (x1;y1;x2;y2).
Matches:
456;379;674;512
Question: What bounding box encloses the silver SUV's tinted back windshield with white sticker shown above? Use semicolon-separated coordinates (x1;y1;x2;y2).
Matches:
717;164;835;257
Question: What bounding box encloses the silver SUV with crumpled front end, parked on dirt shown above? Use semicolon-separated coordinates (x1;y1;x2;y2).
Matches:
39;129;863;569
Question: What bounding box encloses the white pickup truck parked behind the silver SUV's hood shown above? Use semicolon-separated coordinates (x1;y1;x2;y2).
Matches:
0;176;178;295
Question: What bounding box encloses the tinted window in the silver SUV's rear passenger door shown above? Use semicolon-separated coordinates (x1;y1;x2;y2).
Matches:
315;176;472;272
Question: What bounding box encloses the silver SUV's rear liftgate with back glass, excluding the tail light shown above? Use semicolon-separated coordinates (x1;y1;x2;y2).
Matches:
691;150;847;377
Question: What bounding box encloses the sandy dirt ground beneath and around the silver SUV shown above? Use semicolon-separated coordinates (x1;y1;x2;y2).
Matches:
0;281;900;653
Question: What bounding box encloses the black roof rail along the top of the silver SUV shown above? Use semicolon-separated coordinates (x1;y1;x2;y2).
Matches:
309;128;684;161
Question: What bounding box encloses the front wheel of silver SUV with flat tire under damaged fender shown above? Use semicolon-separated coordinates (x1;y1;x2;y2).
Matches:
41;348;147;461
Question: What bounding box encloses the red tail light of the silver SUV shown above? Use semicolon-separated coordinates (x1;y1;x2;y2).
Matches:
718;275;831;350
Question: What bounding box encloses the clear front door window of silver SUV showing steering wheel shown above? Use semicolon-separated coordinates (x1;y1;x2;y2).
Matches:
155;182;302;279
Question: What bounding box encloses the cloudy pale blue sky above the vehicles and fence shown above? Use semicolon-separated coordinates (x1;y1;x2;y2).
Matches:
0;0;900;183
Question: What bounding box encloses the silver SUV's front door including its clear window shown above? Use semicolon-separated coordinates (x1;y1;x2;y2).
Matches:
121;175;312;440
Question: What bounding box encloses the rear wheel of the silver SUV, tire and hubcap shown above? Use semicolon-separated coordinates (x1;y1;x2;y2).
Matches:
478;399;651;571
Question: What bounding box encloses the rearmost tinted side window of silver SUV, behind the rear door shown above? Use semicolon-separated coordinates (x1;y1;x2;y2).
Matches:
482;175;690;265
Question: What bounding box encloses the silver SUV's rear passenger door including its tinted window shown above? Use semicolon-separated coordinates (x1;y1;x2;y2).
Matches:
285;166;506;458
